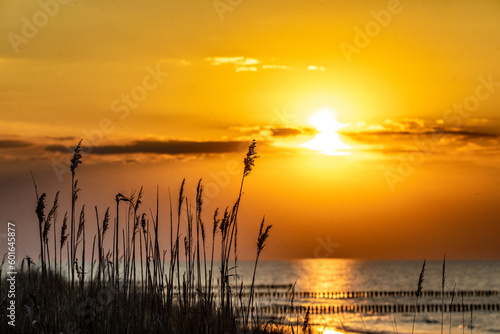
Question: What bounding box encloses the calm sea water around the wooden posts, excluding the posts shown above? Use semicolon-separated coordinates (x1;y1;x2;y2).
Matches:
238;259;500;334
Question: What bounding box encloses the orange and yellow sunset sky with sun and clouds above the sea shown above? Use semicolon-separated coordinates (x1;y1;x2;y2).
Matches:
0;0;500;259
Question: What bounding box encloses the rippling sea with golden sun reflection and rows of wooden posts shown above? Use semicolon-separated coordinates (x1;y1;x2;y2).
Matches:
233;259;500;334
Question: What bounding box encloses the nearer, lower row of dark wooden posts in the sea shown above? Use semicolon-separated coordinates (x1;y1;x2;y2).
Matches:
252;304;500;315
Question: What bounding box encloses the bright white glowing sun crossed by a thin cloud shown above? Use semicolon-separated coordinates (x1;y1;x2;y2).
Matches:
300;108;351;155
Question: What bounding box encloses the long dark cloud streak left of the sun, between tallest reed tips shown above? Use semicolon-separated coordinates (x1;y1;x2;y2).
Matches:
45;140;252;155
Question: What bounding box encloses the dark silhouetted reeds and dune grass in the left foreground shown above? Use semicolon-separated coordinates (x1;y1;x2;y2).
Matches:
0;141;296;334
